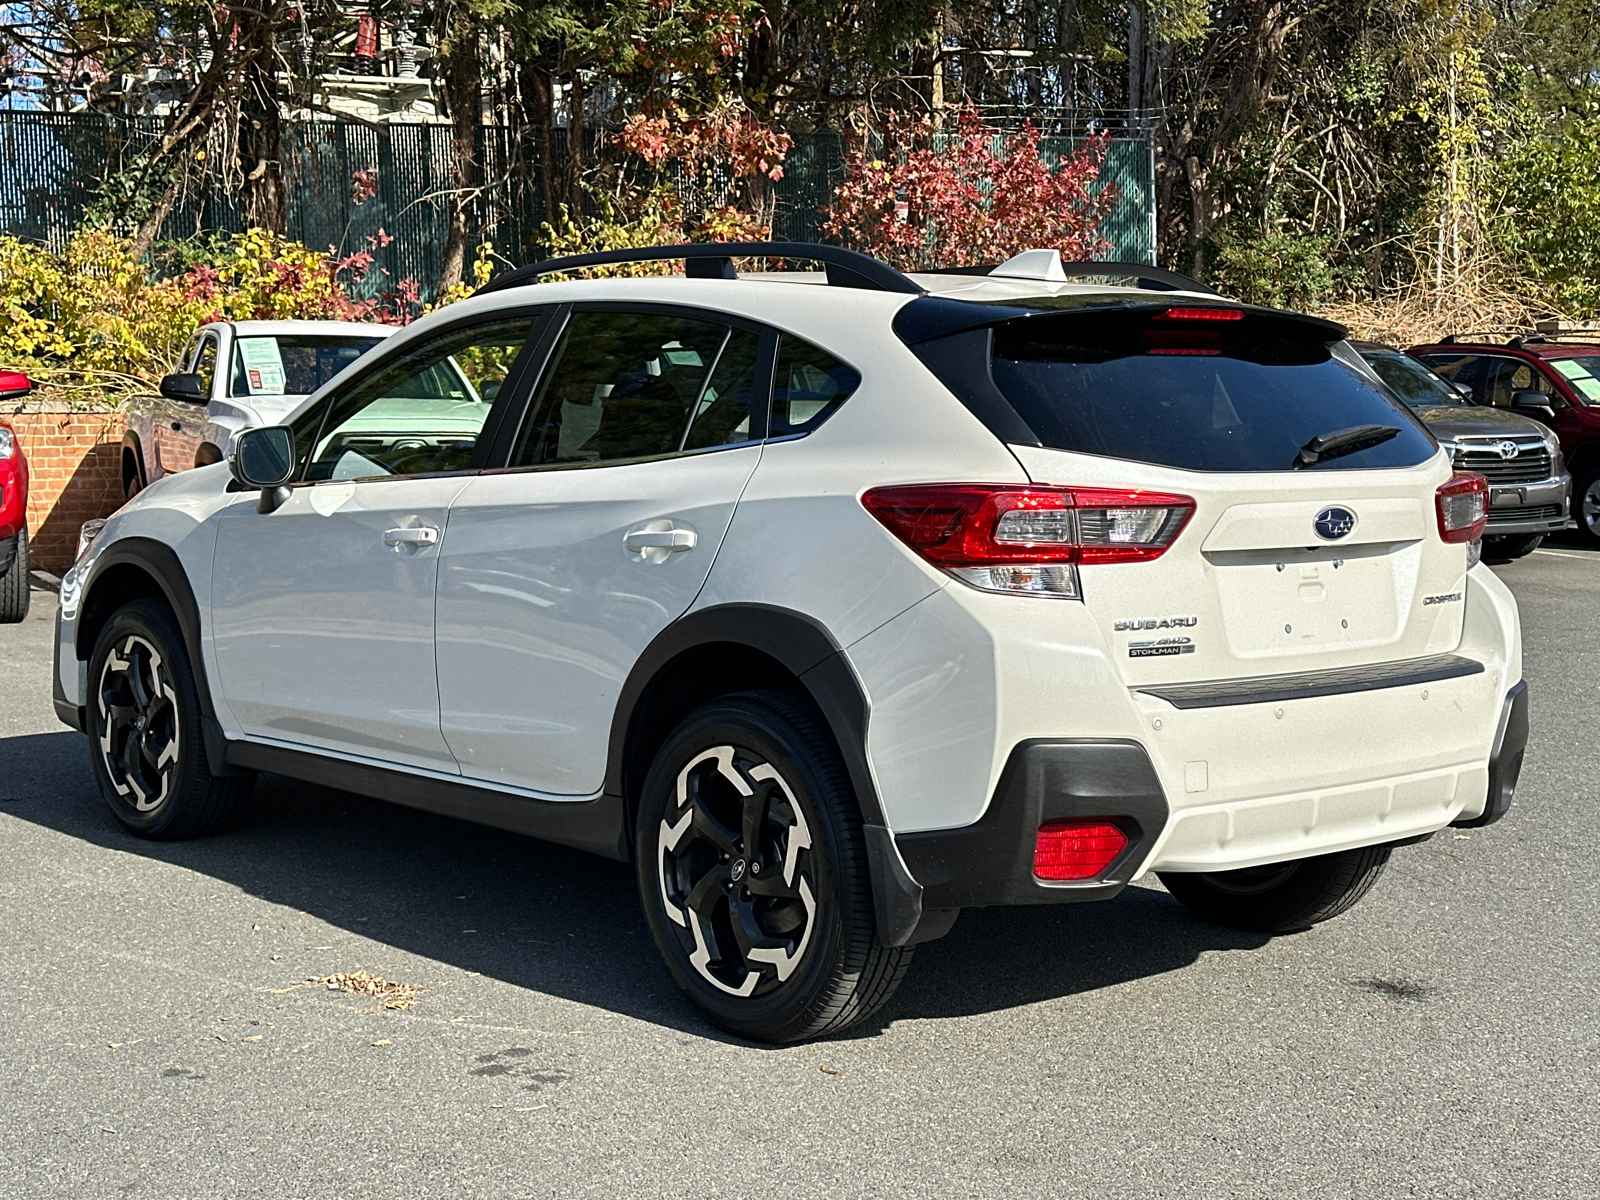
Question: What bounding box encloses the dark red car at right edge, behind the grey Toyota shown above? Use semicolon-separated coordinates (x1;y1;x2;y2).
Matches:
1408;333;1600;547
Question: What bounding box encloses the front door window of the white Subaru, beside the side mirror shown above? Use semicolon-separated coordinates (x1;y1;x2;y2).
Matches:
296;317;531;480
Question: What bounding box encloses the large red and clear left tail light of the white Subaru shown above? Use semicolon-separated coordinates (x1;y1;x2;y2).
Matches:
861;483;1195;597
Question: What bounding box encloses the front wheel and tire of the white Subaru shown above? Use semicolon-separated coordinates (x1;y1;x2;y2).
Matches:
85;600;254;842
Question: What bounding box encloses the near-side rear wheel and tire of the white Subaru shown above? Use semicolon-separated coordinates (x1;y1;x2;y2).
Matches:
635;691;912;1042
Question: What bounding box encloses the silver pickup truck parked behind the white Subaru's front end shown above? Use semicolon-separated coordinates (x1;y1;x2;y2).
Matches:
122;322;394;496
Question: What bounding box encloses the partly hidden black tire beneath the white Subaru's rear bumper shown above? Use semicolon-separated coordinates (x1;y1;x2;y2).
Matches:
1157;846;1392;933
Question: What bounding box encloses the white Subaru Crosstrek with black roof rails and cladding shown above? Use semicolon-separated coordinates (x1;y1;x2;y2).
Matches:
56;243;1528;1042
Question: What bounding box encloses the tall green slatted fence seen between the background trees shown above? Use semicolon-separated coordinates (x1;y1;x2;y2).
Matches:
0;112;1155;298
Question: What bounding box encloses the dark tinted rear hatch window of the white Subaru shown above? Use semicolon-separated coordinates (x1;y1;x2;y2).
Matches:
992;310;1435;470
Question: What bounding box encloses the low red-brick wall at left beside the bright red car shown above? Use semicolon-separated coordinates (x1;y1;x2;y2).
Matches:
0;400;126;574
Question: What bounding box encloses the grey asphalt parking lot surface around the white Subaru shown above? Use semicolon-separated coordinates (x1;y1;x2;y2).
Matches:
0;539;1600;1197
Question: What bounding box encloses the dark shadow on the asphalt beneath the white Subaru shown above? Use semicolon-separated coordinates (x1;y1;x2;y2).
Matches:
0;730;1266;1037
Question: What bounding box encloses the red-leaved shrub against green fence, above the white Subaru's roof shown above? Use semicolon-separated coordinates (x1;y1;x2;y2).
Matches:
824;109;1117;270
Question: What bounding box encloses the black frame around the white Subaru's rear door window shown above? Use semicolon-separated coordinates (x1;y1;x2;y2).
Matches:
483;301;780;475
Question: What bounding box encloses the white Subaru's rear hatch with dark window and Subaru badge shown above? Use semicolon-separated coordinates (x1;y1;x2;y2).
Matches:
914;301;1467;688
